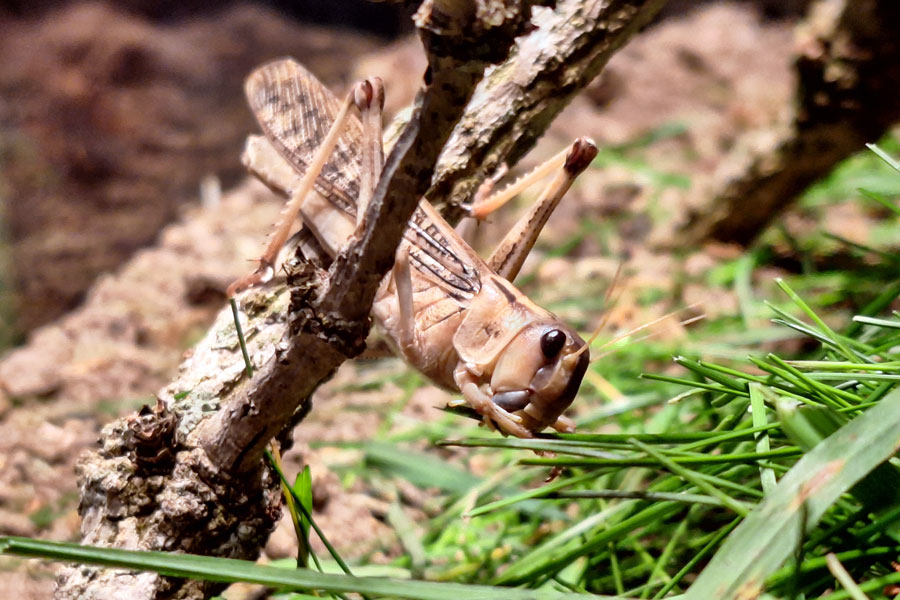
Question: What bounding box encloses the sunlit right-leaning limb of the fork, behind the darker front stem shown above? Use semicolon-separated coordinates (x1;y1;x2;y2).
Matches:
428;0;665;222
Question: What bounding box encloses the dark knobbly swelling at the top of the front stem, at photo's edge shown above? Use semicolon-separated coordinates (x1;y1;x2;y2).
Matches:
413;0;555;63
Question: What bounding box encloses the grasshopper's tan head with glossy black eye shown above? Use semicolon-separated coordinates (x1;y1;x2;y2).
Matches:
490;321;590;433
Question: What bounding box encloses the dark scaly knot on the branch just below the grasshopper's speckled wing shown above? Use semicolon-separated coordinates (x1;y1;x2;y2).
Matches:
285;260;370;358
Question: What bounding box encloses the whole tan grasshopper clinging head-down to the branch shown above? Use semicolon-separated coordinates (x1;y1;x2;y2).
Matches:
228;59;597;437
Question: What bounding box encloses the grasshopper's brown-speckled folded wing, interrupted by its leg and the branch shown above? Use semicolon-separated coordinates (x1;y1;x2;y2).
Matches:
244;59;481;300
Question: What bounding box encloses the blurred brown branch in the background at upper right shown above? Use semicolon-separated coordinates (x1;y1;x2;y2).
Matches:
678;0;900;245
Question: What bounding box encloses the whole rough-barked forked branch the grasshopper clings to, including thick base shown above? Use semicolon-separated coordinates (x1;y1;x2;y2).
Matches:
57;0;661;598
